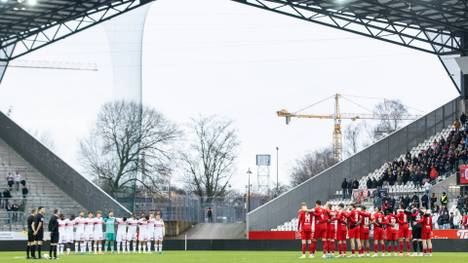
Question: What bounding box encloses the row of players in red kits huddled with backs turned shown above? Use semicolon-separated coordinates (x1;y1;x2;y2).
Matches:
298;200;432;258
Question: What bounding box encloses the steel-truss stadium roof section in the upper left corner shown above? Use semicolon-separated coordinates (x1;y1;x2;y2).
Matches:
0;0;153;61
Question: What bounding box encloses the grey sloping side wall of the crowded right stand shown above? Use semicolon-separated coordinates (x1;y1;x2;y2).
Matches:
247;98;460;231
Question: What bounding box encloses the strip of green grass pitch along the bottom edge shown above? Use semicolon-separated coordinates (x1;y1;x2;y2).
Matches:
0;254;468;263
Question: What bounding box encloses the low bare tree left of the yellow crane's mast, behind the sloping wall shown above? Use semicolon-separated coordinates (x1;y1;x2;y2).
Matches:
291;148;337;186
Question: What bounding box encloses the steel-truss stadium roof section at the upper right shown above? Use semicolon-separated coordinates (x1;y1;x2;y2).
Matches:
232;0;468;55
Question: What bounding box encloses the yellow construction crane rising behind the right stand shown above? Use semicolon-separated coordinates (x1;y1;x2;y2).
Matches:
276;94;421;161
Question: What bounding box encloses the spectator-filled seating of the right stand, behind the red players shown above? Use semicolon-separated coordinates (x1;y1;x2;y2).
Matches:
271;122;468;231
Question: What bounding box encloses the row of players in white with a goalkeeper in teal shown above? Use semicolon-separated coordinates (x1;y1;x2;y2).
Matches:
57;211;166;254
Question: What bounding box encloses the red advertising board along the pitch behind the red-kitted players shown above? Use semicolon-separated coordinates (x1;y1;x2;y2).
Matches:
249;229;468;240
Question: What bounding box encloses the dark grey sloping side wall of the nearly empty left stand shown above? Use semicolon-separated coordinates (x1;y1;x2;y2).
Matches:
0;113;129;218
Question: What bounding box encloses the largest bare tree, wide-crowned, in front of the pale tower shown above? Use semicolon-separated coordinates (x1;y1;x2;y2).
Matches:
79;101;181;196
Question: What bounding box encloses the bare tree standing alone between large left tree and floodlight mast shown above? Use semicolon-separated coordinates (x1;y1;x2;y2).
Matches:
181;116;240;202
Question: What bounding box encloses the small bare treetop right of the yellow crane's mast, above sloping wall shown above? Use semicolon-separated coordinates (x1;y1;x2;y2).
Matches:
373;99;408;140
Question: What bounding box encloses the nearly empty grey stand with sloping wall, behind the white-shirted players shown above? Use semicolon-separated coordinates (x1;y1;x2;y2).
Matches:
0;113;129;231
